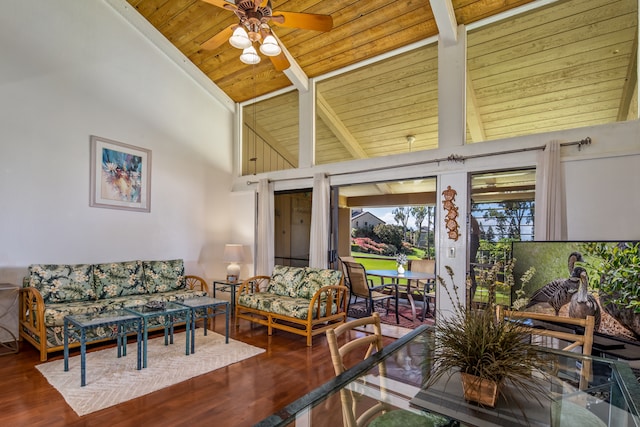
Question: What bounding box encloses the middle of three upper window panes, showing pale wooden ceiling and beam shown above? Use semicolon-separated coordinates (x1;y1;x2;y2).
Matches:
315;44;438;164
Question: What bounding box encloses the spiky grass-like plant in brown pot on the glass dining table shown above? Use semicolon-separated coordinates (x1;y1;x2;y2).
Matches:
425;260;544;407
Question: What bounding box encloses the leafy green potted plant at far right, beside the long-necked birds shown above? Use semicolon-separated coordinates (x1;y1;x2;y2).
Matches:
584;242;640;338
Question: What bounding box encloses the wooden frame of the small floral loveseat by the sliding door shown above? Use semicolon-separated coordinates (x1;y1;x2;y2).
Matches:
235;276;349;347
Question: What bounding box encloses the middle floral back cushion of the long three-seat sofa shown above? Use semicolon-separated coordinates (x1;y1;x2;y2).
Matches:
93;261;147;299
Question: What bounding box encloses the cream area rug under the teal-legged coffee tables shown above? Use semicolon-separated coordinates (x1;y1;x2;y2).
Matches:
36;329;265;416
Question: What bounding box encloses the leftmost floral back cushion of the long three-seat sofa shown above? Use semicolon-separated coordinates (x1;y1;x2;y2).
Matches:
28;264;96;304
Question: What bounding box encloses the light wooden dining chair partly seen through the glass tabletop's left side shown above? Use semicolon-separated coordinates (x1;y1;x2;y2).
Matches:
325;313;458;427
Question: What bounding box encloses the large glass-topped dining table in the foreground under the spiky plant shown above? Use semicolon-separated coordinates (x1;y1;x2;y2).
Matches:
257;325;640;427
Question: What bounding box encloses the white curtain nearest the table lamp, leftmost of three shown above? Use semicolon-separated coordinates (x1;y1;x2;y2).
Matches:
256;178;274;276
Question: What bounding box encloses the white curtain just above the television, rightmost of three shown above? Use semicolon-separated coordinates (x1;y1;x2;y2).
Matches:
534;141;566;240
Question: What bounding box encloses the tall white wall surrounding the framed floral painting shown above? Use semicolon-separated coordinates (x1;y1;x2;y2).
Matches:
0;0;235;284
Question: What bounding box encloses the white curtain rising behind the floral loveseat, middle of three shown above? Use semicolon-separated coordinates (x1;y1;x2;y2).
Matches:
309;173;330;268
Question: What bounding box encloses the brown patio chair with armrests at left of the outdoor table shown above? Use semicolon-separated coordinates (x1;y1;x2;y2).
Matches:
344;261;400;323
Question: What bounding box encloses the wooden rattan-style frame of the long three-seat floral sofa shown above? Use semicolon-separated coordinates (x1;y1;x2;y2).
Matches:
18;276;207;362
